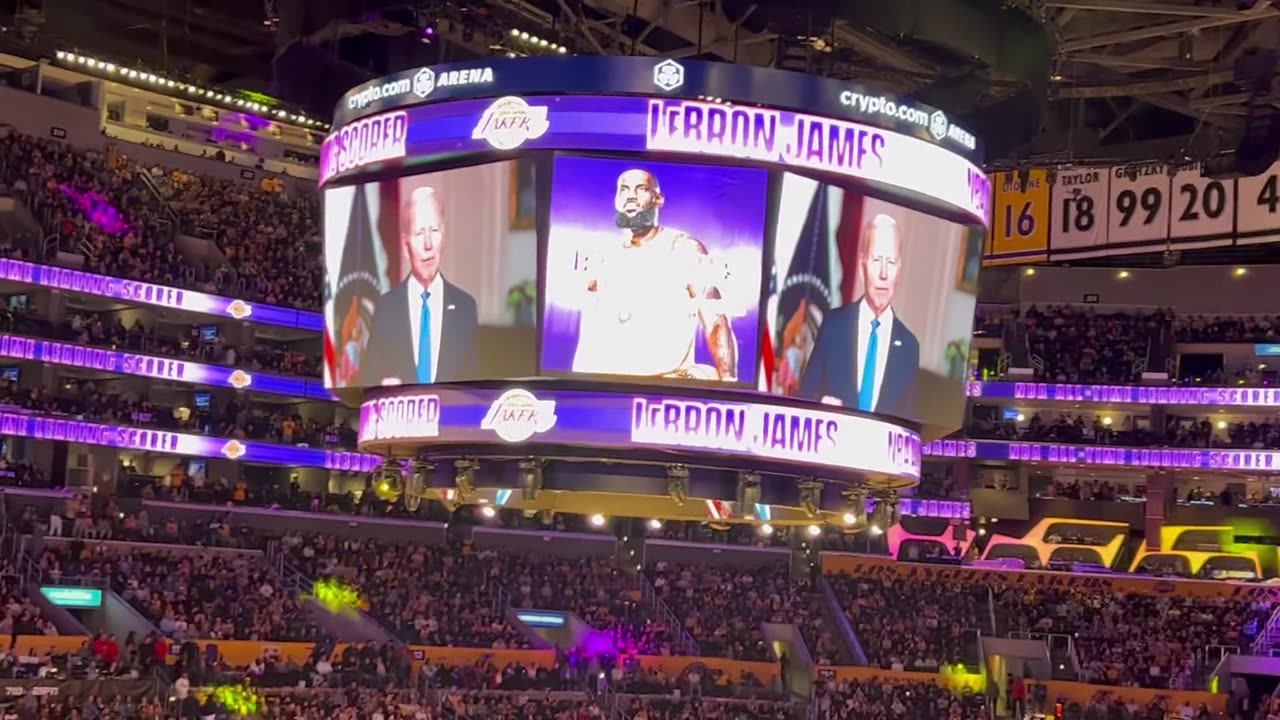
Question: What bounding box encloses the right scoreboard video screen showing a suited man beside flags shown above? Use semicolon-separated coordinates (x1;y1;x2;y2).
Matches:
760;173;983;428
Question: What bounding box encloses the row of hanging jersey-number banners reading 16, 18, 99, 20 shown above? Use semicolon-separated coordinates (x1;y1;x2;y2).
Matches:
986;163;1280;265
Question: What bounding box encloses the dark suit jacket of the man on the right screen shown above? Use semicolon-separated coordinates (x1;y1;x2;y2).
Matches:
800;299;920;418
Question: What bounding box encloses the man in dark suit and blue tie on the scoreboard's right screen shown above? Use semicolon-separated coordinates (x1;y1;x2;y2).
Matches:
800;215;920;418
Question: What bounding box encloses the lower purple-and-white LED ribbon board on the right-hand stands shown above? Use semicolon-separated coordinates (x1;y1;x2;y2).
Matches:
923;439;1280;471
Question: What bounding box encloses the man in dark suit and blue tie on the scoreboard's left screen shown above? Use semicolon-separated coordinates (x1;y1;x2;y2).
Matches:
360;187;479;387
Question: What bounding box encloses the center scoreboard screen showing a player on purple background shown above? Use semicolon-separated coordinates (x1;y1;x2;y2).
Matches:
541;156;768;387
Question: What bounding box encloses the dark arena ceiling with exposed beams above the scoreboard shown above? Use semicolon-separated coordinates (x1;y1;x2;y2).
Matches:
10;0;1280;163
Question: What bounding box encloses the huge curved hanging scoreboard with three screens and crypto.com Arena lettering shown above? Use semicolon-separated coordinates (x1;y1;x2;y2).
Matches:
320;56;991;525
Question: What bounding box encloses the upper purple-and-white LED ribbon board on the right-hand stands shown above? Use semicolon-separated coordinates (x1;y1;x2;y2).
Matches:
965;382;1280;407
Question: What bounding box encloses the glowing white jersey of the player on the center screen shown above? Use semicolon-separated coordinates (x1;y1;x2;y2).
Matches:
573;228;714;377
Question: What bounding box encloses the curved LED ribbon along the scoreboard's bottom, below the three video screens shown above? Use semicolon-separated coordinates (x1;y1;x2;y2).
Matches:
360;388;920;479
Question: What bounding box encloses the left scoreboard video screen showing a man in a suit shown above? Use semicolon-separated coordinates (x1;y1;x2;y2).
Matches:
324;160;538;388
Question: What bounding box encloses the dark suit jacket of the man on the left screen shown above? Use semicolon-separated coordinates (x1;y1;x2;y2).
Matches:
360;278;479;387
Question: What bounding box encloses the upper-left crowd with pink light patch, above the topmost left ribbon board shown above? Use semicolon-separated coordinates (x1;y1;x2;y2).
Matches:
0;128;323;309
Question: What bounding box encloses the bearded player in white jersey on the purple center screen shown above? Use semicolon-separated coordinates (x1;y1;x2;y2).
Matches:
573;169;739;382
